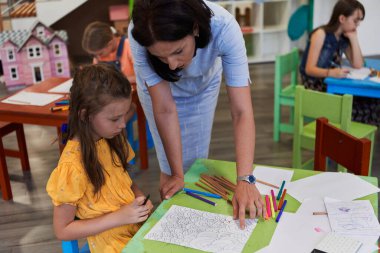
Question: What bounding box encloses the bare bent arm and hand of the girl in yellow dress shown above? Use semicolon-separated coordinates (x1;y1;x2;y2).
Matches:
53;196;150;241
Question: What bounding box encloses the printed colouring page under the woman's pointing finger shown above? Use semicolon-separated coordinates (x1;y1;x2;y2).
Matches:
144;205;257;253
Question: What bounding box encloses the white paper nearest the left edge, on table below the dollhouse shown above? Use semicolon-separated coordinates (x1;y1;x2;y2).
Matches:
1;91;63;106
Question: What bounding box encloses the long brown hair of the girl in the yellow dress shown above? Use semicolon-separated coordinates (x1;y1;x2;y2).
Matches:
68;63;132;193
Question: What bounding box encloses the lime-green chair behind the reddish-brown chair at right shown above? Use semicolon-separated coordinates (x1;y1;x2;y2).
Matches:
293;85;377;175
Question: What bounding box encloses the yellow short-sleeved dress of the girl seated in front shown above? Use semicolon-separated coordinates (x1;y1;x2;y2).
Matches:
46;139;140;253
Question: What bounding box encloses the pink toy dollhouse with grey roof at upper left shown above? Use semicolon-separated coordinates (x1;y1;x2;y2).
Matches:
0;21;70;87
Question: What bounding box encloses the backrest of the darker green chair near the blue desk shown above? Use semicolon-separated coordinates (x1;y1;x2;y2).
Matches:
274;48;299;90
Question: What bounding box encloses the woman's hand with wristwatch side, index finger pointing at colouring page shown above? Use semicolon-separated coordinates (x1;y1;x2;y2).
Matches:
232;181;266;229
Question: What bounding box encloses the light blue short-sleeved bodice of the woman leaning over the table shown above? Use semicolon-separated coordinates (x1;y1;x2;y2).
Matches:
129;1;250;97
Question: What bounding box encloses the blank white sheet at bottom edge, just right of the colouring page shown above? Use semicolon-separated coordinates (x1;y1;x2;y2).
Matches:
258;212;330;253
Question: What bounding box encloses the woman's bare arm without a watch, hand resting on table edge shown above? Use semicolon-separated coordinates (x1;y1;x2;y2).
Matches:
148;81;184;199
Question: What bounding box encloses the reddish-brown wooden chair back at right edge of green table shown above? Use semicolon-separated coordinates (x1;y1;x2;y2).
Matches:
314;118;371;176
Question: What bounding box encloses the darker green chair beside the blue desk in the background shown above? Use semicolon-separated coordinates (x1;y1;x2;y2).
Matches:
273;48;299;142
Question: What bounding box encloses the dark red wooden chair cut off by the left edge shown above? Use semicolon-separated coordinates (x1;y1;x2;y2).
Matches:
0;122;30;200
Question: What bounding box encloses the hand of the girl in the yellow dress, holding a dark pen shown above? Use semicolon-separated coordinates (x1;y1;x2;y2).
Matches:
116;196;153;225
